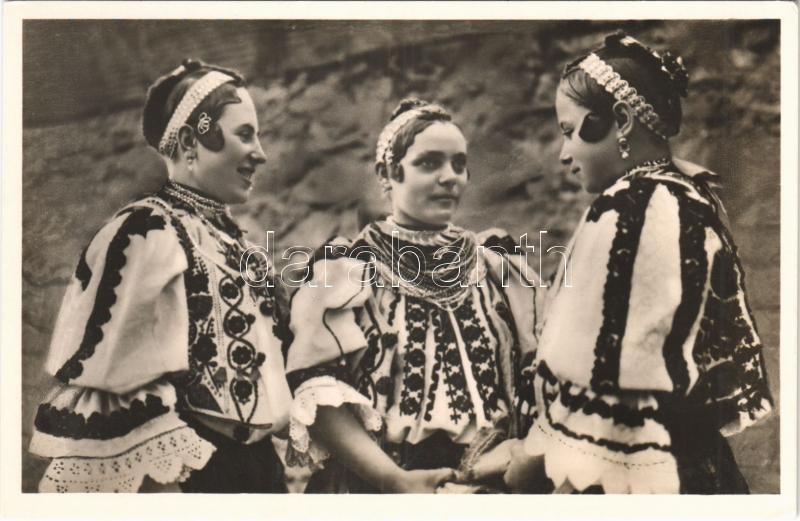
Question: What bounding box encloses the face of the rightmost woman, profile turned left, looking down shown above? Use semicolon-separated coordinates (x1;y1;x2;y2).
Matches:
556;87;625;193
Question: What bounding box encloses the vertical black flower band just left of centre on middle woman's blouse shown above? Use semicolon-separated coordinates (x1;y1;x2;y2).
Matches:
400;297;428;416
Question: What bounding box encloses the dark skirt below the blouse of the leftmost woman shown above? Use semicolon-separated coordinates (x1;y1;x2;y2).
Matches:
180;418;288;494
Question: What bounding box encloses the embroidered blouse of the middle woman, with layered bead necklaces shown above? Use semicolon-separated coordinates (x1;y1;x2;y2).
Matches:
287;216;539;480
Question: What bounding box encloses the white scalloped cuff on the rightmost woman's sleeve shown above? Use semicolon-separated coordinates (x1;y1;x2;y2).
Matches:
524;421;680;494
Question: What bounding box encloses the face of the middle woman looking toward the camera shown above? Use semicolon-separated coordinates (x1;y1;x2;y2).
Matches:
390;121;467;229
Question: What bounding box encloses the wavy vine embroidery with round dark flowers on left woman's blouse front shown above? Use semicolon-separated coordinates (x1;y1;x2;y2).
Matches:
219;275;266;423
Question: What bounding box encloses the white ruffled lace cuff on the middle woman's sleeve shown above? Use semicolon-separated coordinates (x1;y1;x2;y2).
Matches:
286;376;383;470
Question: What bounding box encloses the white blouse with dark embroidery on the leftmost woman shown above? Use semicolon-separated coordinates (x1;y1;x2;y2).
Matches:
30;182;291;492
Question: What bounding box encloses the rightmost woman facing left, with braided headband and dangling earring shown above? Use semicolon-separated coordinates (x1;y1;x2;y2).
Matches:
505;33;772;494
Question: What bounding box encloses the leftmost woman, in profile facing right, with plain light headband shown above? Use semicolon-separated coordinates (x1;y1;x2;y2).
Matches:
31;60;291;492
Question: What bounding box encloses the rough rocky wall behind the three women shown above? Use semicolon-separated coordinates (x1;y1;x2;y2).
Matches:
21;20;780;493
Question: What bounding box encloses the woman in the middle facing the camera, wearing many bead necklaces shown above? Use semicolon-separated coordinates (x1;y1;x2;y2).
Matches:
287;100;538;492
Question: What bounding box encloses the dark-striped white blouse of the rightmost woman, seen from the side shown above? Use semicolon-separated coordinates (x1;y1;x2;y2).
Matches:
525;161;771;493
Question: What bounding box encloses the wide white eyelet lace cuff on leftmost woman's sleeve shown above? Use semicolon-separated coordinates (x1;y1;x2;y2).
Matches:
39;427;215;492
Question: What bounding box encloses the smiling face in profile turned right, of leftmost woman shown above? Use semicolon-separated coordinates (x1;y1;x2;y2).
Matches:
192;87;266;204
